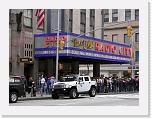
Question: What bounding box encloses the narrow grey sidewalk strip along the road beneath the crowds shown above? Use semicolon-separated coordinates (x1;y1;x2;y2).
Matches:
18;91;139;101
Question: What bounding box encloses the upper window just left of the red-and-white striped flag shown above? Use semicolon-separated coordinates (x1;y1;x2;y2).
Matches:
24;9;32;27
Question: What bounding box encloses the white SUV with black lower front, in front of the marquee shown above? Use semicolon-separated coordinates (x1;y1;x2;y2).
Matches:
52;75;97;99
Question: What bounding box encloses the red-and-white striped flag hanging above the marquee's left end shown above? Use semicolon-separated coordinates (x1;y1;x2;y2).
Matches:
36;9;44;28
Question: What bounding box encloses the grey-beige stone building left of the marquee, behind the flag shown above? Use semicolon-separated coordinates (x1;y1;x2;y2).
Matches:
9;9;47;78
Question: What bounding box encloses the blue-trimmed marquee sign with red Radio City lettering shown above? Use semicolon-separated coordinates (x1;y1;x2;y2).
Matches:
35;32;131;62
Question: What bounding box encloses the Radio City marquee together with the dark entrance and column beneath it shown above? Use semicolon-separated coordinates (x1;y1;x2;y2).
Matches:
34;32;132;77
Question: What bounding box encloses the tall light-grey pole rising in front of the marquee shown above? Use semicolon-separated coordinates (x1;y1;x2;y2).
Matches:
55;9;60;81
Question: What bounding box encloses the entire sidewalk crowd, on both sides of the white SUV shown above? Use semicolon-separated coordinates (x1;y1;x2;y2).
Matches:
26;75;139;96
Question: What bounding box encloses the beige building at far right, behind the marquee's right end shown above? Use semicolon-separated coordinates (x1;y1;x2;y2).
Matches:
101;9;139;76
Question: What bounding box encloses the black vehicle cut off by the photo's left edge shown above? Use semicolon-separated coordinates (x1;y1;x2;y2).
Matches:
9;76;26;103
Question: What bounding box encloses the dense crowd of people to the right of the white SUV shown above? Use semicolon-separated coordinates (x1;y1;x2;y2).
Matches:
95;76;139;93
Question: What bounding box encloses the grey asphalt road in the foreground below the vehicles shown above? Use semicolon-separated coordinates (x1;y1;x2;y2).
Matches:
9;93;139;106
